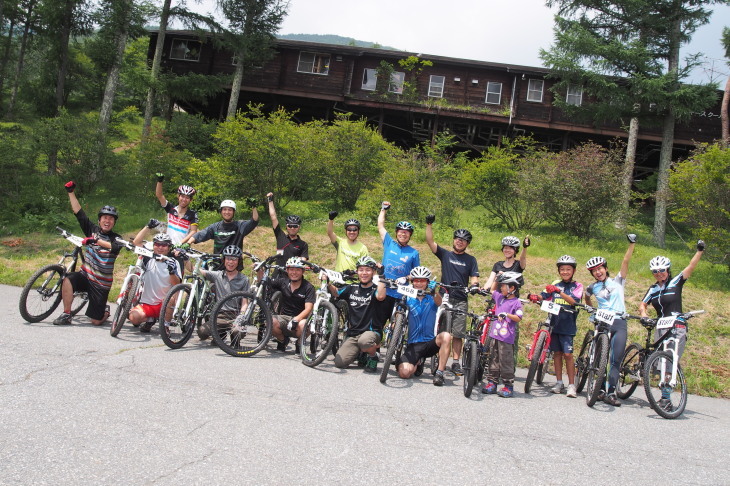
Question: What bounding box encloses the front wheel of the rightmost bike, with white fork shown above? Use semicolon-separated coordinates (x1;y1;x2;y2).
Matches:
644;351;687;419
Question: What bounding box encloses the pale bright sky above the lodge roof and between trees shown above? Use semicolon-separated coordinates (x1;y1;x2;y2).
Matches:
190;0;730;85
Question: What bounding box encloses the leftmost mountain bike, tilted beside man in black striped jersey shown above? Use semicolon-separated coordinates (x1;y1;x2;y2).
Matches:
19;227;89;322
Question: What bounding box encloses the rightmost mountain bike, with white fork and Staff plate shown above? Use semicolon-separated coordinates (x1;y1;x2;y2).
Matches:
616;310;705;419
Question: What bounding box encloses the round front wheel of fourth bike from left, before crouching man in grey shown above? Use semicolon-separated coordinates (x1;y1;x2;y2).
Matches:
210;292;272;358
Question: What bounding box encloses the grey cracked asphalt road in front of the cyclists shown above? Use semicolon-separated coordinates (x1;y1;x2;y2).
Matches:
0;286;730;485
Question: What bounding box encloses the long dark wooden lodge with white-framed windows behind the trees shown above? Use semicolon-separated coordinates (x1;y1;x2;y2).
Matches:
149;31;720;167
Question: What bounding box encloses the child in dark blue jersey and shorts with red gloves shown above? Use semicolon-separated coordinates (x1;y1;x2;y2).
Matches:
530;255;583;398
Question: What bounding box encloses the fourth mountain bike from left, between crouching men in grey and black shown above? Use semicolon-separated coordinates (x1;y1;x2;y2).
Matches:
210;252;282;358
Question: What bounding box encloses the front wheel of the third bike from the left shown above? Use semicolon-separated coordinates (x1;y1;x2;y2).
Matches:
160;283;198;349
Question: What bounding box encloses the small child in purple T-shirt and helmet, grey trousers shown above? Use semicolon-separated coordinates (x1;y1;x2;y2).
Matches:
482;272;522;398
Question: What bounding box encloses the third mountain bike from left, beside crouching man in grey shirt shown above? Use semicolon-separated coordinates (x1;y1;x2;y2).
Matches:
160;248;220;349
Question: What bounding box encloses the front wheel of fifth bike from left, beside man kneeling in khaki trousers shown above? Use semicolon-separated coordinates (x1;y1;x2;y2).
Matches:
299;300;339;367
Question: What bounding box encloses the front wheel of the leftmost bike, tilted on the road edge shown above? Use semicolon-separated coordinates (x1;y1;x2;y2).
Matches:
19;265;66;322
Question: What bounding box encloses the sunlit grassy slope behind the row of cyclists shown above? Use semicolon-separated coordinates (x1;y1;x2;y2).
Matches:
0;205;730;397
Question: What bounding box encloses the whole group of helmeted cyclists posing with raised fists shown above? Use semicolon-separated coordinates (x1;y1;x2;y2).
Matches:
47;174;705;407
